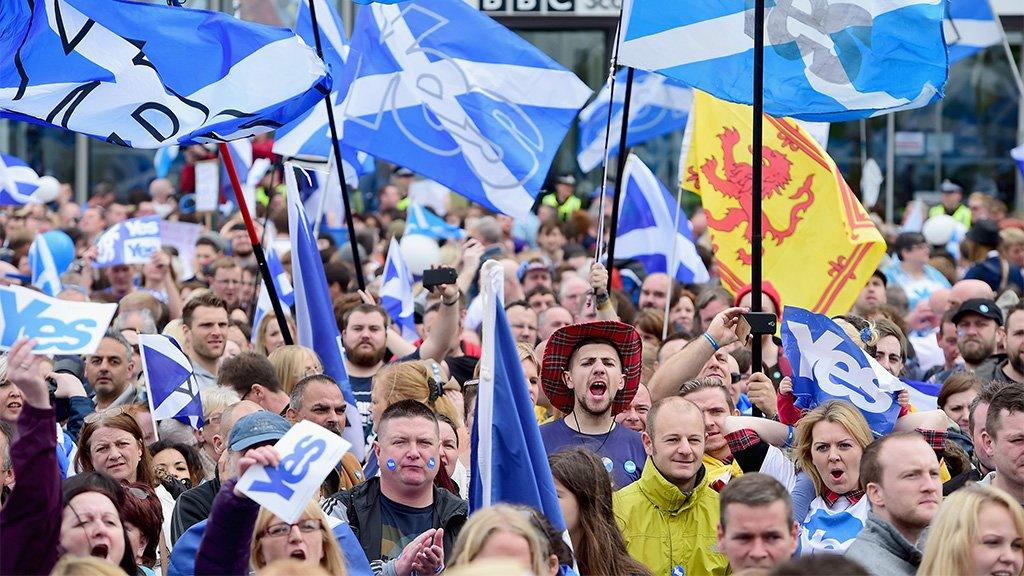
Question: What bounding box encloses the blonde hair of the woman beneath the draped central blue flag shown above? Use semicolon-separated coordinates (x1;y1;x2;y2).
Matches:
449;504;551;574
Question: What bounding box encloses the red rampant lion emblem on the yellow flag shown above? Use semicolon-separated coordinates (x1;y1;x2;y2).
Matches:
687;128;814;265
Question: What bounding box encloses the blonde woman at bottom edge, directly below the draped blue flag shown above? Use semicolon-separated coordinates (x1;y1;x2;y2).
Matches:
449;504;559;576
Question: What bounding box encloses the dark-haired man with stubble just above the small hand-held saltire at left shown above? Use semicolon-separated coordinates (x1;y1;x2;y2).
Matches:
181;292;228;389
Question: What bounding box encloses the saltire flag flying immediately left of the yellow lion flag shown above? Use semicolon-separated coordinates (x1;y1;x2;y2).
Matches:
615;154;711;284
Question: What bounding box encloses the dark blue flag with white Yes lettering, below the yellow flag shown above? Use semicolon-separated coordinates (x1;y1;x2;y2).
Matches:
782;306;906;437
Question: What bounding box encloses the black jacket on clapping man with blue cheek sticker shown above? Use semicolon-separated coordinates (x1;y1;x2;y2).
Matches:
324;478;469;565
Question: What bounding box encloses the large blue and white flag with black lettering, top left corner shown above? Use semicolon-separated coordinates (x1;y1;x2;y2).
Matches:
0;0;331;148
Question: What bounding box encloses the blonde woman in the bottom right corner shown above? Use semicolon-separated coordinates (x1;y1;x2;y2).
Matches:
918;484;1024;576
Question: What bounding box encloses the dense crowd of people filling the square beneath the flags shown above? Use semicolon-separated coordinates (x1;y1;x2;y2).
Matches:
0;152;1024;576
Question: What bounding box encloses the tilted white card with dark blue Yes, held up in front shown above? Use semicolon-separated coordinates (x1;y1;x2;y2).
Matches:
238;420;349;523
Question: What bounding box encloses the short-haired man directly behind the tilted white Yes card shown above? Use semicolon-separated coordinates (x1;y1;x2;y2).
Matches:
285;374;364;494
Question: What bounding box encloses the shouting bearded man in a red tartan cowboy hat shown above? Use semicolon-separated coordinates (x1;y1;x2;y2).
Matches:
541;321;647;489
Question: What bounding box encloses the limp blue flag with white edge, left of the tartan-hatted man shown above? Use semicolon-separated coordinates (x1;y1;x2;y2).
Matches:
469;262;565;531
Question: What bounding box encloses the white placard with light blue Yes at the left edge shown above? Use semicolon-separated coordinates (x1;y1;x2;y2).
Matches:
0;286;118;354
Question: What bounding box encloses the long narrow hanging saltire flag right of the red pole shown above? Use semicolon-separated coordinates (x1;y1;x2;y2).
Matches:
285;163;366;461
